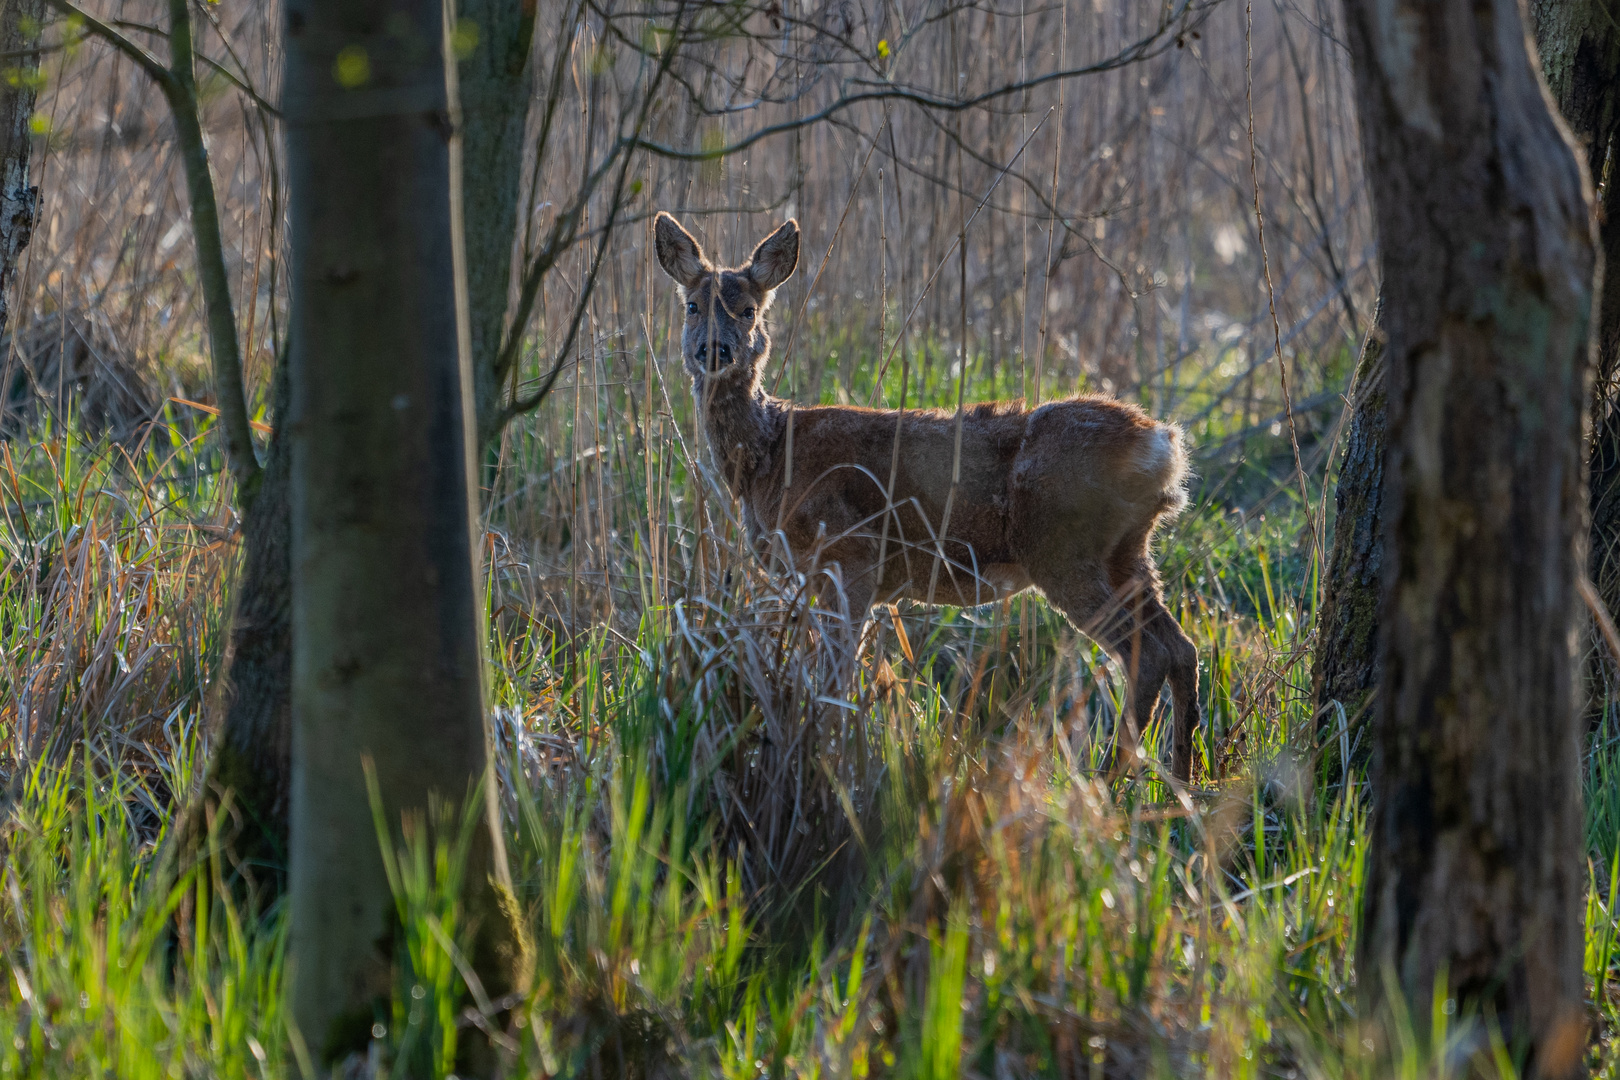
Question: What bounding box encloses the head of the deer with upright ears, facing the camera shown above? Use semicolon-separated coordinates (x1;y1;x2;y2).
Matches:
653;212;799;389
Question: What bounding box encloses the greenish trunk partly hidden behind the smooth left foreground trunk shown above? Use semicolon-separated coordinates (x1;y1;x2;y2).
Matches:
457;0;535;449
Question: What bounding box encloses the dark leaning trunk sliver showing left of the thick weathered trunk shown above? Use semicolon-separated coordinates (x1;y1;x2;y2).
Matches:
1312;304;1388;766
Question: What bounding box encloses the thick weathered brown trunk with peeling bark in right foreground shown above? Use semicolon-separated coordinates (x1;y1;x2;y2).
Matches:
1345;0;1596;1077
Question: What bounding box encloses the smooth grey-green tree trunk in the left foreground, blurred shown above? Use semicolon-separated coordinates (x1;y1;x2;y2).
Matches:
284;0;522;1061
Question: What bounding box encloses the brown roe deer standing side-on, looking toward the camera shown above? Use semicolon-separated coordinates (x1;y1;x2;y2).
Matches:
653;214;1199;780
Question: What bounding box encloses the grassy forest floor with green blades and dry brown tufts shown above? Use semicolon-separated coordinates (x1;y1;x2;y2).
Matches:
0;331;1620;1080
